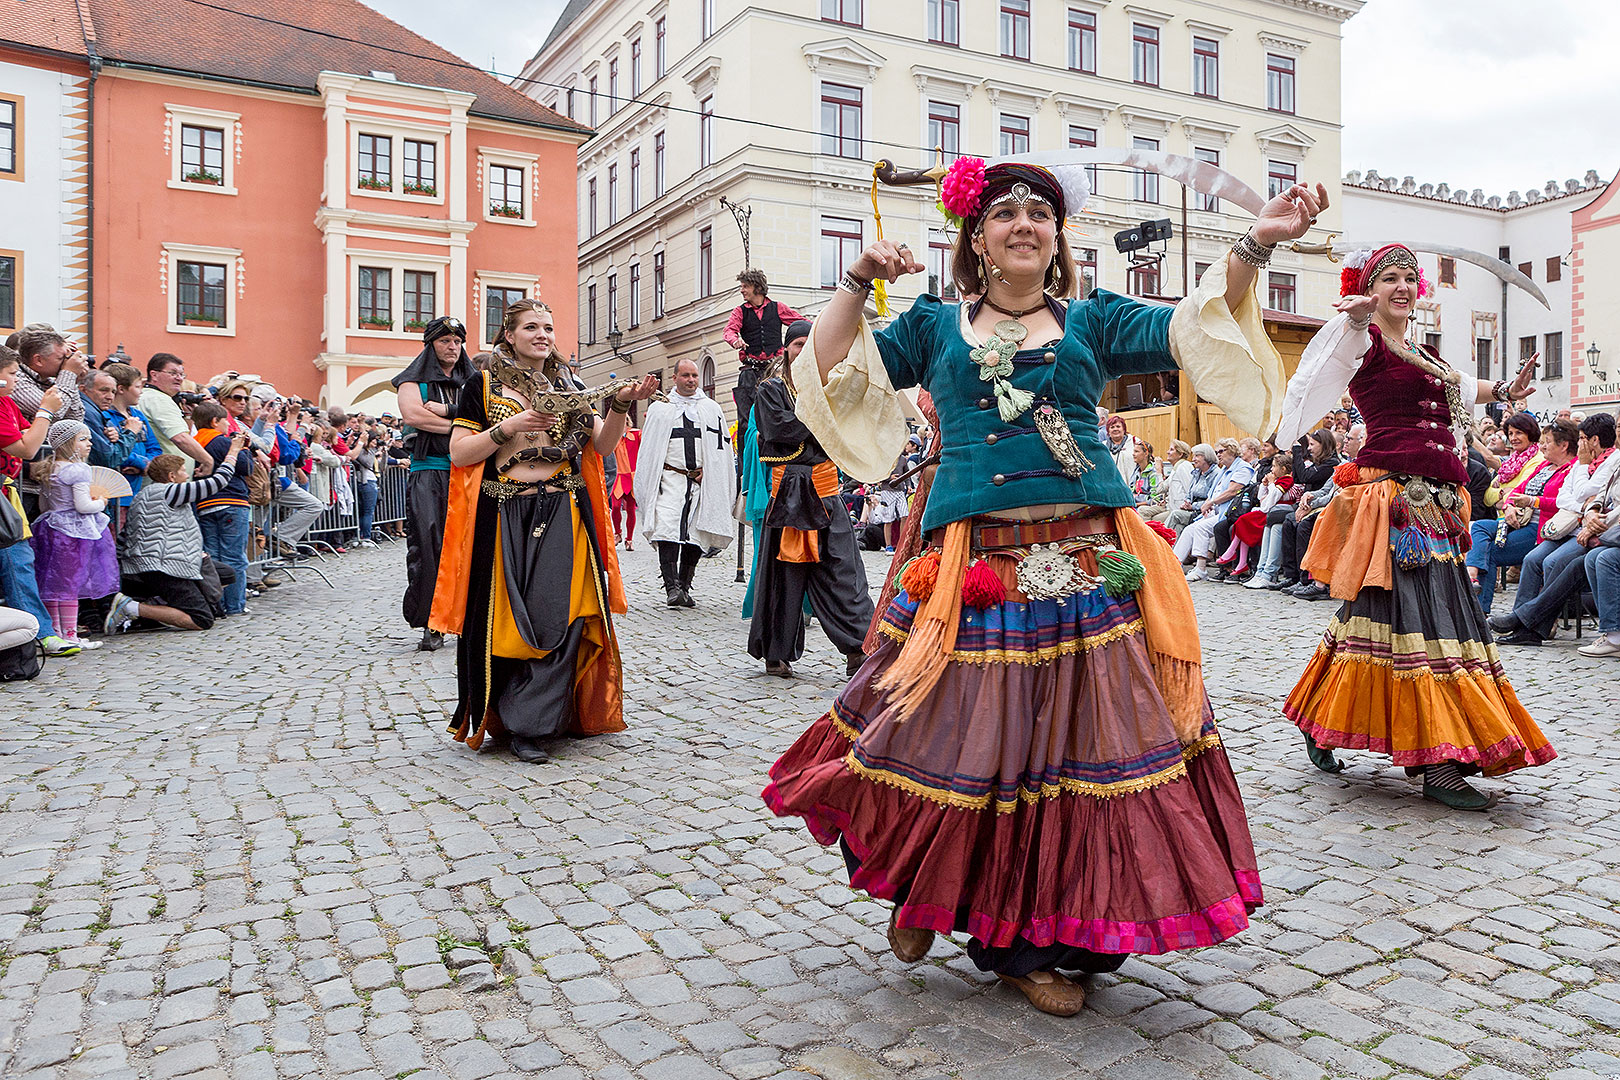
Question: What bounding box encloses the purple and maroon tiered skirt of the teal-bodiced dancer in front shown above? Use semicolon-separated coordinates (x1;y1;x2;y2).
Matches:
765;555;1262;973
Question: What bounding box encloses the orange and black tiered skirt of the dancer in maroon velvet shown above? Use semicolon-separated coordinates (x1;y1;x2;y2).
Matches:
1283;470;1557;776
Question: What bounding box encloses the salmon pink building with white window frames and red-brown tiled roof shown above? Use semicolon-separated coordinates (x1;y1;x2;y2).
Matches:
82;0;590;404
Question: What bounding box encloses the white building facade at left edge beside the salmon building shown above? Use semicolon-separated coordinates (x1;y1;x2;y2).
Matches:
0;42;89;340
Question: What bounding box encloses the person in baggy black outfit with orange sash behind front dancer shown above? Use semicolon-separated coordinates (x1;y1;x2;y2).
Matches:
748;319;872;678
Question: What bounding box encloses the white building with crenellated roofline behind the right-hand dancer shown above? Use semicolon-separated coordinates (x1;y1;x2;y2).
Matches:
1343;172;1604;418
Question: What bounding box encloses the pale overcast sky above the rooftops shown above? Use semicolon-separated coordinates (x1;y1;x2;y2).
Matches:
369;0;1620;196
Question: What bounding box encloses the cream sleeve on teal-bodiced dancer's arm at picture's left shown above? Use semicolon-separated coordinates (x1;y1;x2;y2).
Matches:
794;319;906;484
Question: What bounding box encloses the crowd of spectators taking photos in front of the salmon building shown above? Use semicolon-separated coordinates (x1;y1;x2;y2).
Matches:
0;324;408;656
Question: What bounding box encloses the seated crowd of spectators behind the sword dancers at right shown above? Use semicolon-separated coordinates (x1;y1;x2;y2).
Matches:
1100;397;1620;656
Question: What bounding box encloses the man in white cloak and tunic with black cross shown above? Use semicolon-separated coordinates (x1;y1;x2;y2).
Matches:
635;359;737;607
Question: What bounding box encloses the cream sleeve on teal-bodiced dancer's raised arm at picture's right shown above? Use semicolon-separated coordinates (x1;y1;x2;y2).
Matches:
1170;259;1288;436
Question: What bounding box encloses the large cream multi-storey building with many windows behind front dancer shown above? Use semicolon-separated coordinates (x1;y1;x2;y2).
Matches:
517;0;1361;420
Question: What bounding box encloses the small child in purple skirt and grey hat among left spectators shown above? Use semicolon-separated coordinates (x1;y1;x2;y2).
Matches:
34;419;118;649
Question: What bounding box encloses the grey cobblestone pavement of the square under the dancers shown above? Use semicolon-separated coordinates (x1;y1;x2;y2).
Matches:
0;547;1620;1080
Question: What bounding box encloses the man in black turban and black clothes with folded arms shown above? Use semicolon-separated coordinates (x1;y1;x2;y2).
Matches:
392;316;473;653
